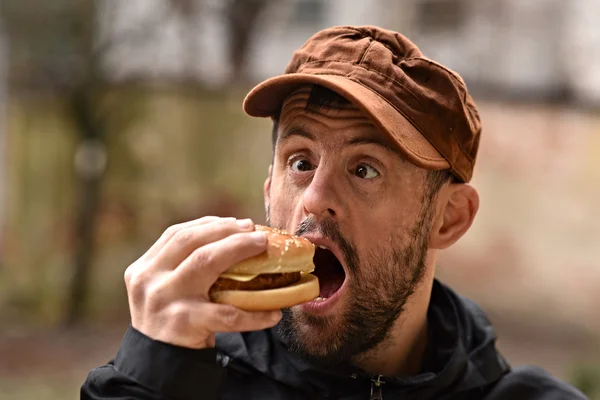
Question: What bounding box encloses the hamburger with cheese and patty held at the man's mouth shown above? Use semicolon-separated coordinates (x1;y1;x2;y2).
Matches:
209;225;319;311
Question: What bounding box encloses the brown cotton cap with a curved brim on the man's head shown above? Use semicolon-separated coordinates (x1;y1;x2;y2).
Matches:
244;26;481;182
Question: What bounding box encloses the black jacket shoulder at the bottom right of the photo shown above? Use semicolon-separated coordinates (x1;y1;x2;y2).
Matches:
486;366;587;400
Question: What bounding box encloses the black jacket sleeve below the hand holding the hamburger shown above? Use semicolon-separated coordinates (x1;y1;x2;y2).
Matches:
81;327;225;400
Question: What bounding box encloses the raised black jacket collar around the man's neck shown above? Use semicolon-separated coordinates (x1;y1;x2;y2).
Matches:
217;280;509;398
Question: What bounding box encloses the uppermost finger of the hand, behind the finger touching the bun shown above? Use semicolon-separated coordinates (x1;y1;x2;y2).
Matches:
151;218;254;270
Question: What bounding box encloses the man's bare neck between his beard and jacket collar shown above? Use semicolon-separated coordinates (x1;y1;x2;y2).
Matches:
354;254;437;376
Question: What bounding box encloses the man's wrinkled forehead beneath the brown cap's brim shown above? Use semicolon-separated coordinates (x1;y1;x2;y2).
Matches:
278;86;393;149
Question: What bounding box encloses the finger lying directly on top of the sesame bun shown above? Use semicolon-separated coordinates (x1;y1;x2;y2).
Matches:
169;231;267;295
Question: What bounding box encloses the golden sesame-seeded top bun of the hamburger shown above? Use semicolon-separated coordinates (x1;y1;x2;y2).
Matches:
225;225;315;275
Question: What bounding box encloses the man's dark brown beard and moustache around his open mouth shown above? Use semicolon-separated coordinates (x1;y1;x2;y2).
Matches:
267;201;433;366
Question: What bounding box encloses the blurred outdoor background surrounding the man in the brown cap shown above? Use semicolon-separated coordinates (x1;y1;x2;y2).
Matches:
0;0;600;400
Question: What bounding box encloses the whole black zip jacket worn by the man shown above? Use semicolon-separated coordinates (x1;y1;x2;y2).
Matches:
81;281;585;400
